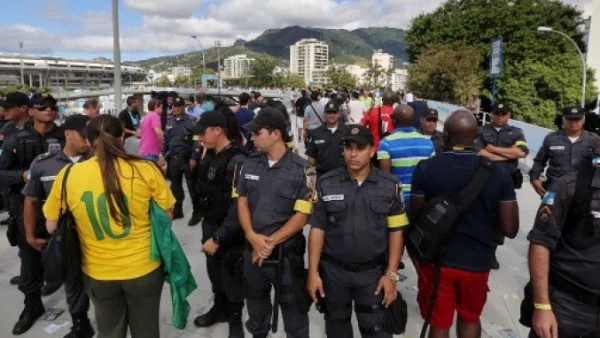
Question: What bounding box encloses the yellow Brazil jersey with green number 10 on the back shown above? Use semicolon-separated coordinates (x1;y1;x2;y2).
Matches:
44;157;175;280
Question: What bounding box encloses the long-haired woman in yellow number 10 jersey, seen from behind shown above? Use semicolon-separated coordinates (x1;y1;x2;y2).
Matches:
44;115;175;338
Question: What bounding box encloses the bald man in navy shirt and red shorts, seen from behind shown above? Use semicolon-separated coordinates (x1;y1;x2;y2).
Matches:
409;111;519;338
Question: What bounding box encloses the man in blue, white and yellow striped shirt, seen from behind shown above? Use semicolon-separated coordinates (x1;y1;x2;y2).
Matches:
377;104;435;205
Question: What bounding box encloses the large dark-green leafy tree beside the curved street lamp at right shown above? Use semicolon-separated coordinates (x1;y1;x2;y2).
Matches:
404;0;597;126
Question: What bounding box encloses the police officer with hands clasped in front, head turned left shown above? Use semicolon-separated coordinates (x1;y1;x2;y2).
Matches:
238;107;316;338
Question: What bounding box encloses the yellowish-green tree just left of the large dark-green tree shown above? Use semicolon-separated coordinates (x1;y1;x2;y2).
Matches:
407;42;481;105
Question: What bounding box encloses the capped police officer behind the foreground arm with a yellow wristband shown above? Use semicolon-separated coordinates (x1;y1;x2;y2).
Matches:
529;107;600;196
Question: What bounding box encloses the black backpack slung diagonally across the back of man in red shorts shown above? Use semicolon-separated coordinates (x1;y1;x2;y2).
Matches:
406;157;494;264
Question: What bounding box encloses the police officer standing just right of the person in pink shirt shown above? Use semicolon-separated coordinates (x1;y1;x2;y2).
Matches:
159;97;201;225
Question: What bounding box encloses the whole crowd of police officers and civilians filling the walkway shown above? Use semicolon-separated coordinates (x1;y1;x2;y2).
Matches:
0;86;600;338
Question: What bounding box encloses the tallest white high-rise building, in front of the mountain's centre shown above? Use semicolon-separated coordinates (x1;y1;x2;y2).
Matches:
290;39;329;84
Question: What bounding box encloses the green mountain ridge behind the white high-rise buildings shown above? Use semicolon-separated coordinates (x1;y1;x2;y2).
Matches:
136;26;408;70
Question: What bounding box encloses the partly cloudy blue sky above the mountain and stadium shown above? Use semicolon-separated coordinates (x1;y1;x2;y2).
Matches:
0;0;600;61
